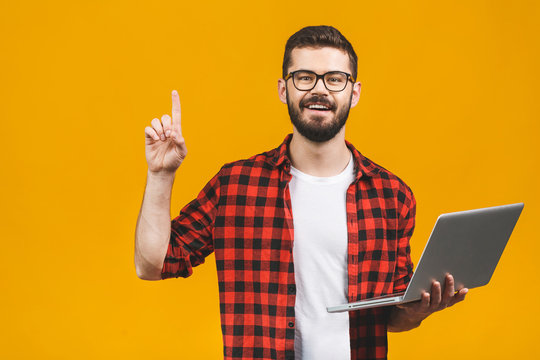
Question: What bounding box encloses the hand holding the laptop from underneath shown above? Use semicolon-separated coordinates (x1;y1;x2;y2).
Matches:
396;274;469;322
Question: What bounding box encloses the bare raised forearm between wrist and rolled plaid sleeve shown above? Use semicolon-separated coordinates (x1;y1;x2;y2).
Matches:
135;171;175;280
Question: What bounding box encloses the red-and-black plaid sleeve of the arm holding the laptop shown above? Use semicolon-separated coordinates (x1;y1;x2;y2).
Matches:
394;186;416;292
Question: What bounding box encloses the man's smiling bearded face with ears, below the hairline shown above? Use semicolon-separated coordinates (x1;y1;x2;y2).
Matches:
278;47;360;142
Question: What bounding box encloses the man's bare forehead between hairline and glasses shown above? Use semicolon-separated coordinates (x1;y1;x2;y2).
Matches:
289;47;351;73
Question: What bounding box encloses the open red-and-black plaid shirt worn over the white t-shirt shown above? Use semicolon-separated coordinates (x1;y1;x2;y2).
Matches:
161;134;416;359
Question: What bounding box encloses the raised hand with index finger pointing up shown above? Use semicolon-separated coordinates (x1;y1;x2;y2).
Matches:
144;90;187;174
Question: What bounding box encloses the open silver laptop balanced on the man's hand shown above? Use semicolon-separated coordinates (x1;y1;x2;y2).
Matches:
326;203;523;313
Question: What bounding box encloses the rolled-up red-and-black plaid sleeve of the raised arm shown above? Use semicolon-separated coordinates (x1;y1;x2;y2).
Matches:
161;173;219;279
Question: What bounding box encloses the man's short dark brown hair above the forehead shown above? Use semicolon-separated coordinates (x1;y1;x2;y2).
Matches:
283;25;358;79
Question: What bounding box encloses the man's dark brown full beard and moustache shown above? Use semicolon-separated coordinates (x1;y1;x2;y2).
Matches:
287;93;352;143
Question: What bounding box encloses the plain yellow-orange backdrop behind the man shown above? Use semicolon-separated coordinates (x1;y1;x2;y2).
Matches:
0;0;540;359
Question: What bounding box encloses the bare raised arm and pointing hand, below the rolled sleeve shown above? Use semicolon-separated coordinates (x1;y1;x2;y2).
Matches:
135;91;187;280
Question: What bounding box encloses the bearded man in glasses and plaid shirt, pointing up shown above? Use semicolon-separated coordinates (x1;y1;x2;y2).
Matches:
135;26;467;359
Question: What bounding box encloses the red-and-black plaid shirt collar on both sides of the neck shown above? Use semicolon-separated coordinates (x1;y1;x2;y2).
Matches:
270;134;379;180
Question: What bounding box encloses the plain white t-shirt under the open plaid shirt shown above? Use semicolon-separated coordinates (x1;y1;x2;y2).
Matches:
289;153;355;360
